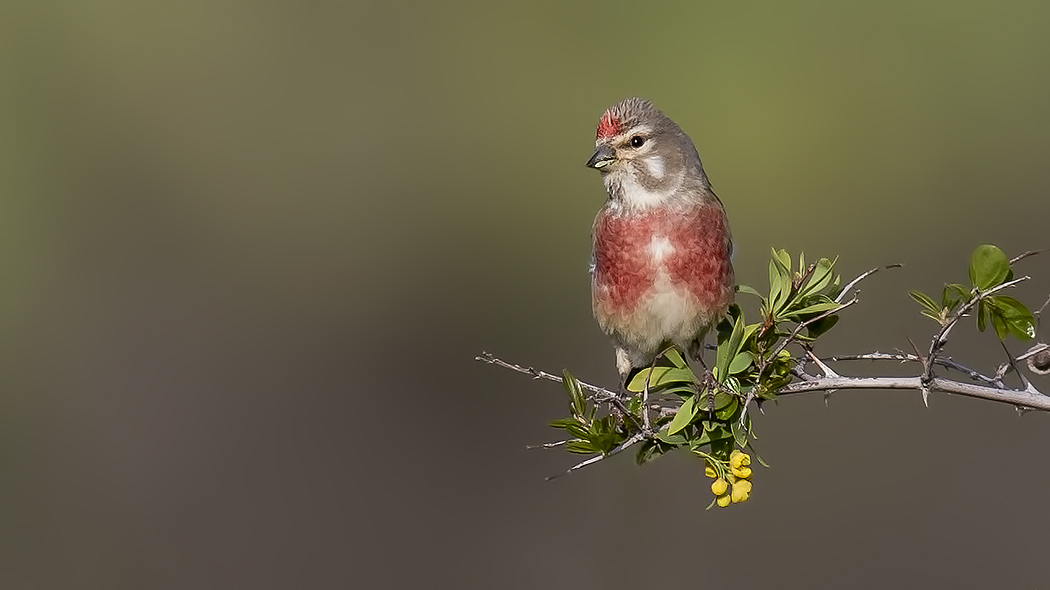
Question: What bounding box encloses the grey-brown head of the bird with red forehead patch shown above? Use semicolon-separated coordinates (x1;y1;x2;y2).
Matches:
587;99;708;206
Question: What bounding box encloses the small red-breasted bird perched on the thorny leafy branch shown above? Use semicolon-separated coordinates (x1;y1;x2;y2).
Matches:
587;98;734;394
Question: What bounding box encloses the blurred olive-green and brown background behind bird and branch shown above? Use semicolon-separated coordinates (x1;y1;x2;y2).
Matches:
0;0;1050;589
